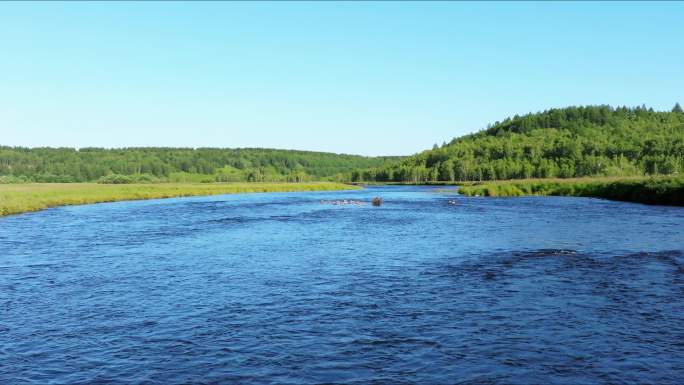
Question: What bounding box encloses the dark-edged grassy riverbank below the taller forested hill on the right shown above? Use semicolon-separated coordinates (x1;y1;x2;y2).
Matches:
459;176;684;206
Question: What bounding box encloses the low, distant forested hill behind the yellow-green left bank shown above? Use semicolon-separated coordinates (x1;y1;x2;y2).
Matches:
0;146;402;183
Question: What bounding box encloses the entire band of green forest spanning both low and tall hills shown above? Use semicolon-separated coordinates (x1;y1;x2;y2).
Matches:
0;104;684;183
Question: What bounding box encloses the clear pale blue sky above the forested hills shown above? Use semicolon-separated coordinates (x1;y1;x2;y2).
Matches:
0;2;684;155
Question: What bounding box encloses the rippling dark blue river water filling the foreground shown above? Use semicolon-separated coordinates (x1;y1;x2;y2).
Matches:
0;187;684;385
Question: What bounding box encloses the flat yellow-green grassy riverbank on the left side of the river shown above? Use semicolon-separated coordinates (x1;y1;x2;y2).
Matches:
0;182;358;216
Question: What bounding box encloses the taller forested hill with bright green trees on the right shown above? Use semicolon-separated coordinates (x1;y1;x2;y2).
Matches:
353;104;684;183
